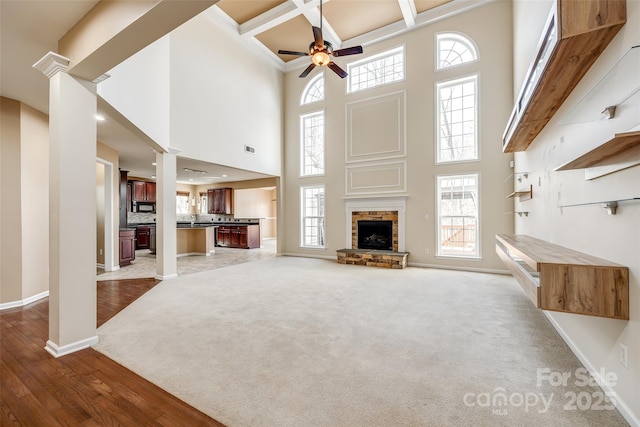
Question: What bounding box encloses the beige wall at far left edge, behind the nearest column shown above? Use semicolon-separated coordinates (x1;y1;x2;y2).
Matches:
0;97;49;307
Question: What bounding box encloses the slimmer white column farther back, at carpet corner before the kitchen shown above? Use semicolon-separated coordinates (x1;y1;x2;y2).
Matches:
156;148;180;280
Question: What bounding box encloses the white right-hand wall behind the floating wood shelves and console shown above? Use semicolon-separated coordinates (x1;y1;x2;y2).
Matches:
514;1;640;425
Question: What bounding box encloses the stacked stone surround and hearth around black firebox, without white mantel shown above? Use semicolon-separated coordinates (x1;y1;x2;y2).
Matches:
336;211;409;268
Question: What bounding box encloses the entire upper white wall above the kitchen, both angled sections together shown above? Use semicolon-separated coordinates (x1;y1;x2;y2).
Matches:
98;14;283;176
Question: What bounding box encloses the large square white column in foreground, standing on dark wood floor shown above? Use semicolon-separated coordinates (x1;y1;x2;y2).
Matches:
34;52;98;357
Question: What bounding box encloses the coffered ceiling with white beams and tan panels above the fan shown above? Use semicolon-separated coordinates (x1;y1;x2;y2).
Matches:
207;0;486;71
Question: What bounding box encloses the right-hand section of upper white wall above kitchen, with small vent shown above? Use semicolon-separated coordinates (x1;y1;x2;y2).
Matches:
170;14;283;175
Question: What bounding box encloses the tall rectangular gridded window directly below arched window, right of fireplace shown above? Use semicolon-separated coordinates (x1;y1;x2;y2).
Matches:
436;75;478;163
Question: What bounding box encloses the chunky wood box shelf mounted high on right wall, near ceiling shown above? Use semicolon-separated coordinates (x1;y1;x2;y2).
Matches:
502;0;627;153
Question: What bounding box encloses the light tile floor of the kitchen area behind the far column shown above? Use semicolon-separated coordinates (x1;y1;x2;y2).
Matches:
97;239;276;281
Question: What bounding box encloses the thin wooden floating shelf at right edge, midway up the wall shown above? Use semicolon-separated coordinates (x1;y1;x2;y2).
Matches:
555;131;640;171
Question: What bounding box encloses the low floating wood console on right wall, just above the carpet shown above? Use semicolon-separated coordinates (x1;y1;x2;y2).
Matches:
496;234;629;320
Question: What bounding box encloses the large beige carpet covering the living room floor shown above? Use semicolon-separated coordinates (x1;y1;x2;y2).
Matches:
95;257;627;427
